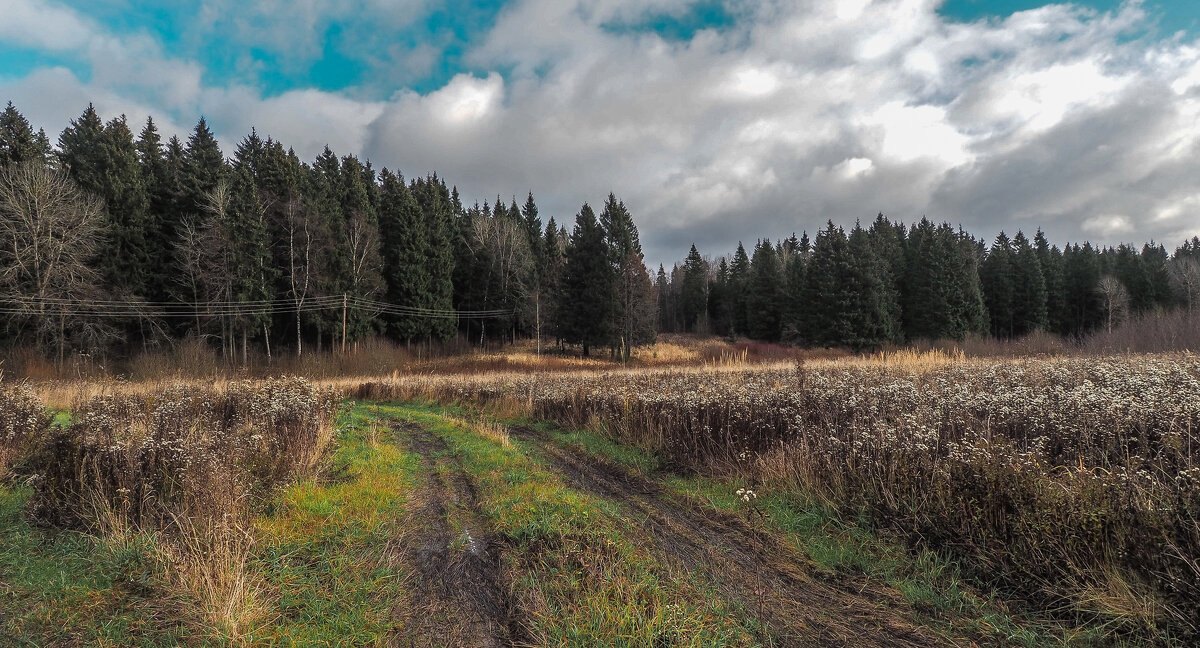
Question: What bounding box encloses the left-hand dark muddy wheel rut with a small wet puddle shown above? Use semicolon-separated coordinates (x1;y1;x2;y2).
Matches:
391;424;523;648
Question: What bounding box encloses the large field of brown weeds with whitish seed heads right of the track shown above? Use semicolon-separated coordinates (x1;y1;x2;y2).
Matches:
356;353;1200;641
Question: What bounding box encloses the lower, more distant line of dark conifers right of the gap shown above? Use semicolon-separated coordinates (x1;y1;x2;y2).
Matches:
655;214;1200;349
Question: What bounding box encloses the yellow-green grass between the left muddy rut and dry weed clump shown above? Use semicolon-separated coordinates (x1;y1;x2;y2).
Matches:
251;406;420;647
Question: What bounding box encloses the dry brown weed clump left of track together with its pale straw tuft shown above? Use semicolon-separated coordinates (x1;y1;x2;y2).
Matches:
15;378;340;643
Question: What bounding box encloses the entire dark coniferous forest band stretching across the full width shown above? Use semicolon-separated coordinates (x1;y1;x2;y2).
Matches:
0;103;1200;359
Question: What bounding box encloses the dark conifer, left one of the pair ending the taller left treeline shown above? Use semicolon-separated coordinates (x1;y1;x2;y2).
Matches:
557;203;613;356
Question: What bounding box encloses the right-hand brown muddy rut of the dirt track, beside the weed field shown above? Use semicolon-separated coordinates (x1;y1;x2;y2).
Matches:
511;427;953;648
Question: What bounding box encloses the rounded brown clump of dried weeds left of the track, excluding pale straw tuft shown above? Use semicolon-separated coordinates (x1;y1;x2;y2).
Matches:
31;378;337;528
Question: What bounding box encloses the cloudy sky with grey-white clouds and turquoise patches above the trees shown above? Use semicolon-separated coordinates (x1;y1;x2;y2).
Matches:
0;0;1200;263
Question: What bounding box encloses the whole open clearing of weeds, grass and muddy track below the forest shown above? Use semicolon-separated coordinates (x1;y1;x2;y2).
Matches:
0;346;1200;647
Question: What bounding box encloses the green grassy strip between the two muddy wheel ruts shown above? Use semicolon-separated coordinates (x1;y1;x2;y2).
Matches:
397;406;761;648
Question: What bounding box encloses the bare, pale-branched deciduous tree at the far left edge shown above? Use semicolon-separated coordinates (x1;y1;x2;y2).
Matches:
0;163;112;362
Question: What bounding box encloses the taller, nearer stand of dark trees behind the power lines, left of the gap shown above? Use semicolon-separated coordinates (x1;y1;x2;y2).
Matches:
0;102;655;359
